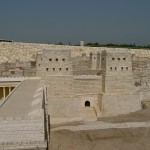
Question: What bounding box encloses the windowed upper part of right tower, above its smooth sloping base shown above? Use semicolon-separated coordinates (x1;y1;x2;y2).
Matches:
105;52;135;94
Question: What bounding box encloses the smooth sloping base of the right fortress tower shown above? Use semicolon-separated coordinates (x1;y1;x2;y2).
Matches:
101;93;141;117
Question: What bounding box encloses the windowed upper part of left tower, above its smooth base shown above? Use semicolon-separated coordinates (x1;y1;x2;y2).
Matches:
36;50;73;96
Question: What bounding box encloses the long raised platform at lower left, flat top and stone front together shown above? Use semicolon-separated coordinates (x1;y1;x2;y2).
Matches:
0;79;47;150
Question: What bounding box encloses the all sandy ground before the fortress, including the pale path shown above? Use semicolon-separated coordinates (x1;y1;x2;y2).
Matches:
49;109;150;150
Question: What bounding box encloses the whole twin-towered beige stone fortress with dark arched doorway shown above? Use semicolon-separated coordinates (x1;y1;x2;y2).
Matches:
36;50;141;123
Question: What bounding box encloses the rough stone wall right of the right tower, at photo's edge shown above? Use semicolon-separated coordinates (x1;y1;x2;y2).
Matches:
132;56;150;108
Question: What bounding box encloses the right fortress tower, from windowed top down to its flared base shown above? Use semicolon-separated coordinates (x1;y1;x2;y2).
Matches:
102;52;141;116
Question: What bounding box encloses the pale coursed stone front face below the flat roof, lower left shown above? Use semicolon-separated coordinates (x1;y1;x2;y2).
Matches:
0;120;45;143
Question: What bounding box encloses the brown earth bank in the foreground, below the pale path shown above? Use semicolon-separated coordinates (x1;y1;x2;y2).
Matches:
49;128;150;150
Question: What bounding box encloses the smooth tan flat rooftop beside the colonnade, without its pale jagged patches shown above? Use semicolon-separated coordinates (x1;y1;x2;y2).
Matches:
0;79;40;117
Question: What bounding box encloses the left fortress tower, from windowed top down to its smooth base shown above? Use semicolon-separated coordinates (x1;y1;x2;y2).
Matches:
36;50;82;123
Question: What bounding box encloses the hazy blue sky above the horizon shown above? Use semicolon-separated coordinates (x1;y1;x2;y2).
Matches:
0;0;150;45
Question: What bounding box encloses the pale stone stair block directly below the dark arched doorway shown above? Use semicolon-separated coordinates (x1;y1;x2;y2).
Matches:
82;107;97;121
